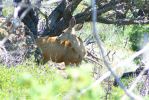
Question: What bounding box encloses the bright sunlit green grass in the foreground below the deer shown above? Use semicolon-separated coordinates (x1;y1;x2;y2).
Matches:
0;63;106;100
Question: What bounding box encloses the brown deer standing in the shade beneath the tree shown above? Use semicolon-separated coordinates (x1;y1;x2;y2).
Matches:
36;18;86;65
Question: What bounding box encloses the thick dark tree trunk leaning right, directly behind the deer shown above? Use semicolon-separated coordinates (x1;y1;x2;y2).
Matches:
44;0;82;36
